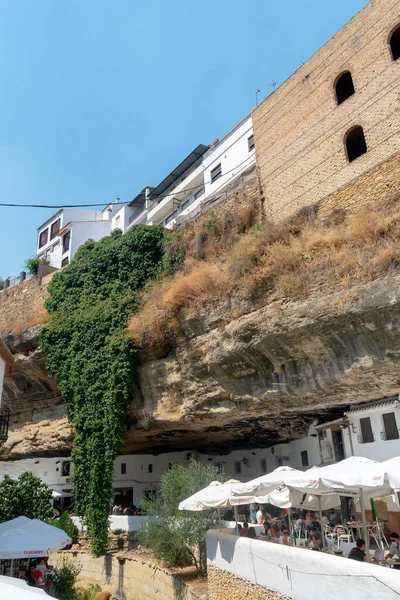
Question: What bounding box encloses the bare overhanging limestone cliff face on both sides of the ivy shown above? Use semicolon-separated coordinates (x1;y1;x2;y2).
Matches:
2;276;400;459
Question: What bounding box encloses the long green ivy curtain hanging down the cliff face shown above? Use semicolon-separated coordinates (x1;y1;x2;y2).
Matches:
41;225;163;555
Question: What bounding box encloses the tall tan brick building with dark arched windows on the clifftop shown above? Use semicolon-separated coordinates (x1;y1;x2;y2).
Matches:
253;0;400;220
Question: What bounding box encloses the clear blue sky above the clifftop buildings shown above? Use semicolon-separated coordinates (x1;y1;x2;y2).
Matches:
0;0;367;277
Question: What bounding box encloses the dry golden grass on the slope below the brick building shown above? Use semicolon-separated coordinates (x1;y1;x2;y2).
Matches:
129;199;400;345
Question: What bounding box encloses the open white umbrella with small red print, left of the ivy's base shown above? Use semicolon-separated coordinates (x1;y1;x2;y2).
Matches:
0;517;72;560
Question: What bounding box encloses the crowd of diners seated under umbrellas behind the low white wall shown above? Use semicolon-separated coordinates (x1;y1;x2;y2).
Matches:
225;503;400;569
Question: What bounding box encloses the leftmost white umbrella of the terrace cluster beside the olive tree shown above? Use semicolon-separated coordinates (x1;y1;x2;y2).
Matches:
179;479;253;511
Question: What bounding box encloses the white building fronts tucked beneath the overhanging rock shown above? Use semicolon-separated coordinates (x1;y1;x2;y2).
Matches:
0;396;400;531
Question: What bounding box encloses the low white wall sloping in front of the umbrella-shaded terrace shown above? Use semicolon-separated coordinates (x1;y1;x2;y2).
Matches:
207;530;400;600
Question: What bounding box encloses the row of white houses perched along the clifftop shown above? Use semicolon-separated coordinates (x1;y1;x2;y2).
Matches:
36;114;256;269
